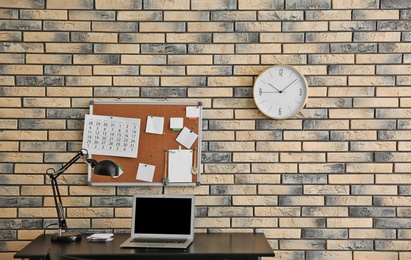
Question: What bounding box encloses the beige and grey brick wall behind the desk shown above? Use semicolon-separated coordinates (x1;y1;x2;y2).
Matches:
0;0;411;260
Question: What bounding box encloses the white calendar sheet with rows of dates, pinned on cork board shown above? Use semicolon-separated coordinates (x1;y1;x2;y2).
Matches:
83;115;140;158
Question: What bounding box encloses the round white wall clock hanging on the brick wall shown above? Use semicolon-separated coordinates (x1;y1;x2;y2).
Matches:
253;65;308;119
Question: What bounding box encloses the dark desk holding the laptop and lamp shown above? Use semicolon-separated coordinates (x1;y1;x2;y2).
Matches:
14;233;274;260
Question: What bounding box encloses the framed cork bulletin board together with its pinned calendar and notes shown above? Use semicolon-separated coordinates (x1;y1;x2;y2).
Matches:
83;100;202;186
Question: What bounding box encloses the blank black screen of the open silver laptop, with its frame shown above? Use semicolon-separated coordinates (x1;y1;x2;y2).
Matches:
132;195;194;235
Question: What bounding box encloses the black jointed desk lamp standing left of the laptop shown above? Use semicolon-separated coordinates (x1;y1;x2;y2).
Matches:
46;149;119;242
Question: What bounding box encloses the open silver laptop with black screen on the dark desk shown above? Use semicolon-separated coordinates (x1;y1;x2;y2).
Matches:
120;195;195;249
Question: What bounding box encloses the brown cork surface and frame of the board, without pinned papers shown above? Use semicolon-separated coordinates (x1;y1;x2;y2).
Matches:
88;101;202;186
